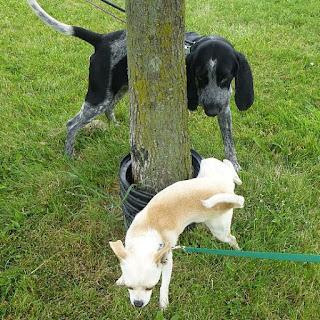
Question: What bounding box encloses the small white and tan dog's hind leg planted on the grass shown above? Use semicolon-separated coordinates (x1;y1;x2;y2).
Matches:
205;209;241;250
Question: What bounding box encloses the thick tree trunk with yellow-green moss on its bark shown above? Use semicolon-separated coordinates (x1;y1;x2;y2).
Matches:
126;0;192;192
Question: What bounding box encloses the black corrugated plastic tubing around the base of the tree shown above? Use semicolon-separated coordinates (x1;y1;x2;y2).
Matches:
120;149;202;229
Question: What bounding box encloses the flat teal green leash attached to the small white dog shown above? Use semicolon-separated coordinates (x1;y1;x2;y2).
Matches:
174;246;320;263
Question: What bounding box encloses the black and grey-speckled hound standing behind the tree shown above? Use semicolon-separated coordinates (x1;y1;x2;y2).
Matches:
27;0;254;170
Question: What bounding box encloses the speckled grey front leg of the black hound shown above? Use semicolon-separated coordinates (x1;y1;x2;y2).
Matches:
218;106;241;171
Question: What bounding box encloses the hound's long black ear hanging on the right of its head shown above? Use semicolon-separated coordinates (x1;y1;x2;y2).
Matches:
235;52;254;111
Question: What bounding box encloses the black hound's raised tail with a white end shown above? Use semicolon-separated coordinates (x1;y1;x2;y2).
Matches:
27;0;102;47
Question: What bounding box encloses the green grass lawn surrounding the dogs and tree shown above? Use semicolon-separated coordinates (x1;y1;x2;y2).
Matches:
0;0;320;320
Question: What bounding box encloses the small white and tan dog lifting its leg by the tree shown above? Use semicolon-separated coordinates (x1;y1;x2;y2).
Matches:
110;158;244;309
